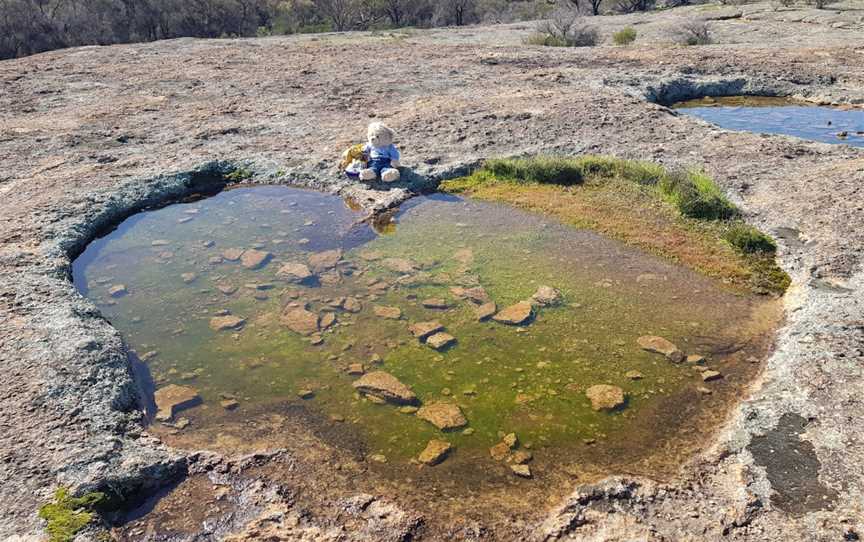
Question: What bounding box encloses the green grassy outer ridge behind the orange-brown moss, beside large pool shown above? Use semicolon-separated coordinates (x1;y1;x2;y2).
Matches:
440;155;791;293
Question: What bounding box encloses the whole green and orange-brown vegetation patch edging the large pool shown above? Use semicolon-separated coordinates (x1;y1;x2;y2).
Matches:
441;156;790;294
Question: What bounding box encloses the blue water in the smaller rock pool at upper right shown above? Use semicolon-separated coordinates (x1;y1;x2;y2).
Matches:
673;96;864;147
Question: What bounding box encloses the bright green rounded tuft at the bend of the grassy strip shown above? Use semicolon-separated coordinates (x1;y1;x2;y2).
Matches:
658;170;738;220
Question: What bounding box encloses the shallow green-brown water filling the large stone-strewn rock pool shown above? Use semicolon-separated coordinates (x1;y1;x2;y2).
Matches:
74;187;775;483
